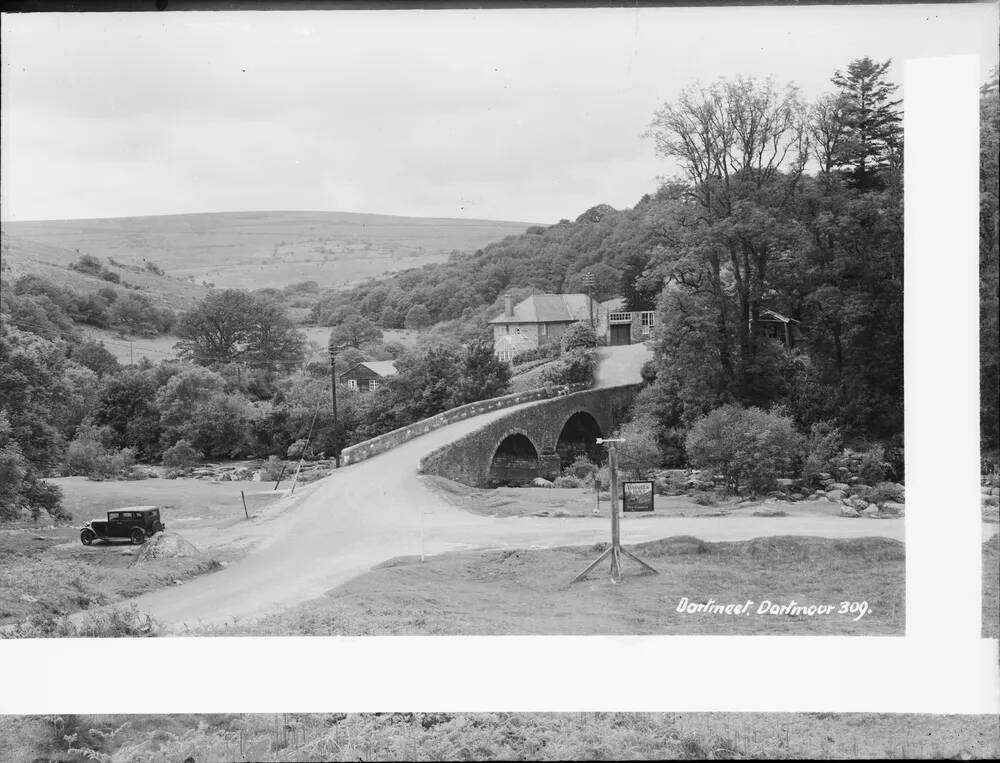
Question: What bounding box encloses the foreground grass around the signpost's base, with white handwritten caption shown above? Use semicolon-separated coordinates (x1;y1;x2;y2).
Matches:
201;537;905;636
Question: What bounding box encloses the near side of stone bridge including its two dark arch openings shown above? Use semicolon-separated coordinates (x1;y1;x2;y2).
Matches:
419;384;640;487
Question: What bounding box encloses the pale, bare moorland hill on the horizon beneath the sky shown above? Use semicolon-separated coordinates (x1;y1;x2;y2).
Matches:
0;212;531;289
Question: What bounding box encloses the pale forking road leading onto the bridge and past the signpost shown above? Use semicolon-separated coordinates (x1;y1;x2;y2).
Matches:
117;388;903;628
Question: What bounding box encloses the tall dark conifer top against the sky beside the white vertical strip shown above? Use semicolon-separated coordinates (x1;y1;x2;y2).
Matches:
831;56;903;189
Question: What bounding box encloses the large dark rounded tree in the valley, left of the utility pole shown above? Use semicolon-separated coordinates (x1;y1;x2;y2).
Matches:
176;289;305;369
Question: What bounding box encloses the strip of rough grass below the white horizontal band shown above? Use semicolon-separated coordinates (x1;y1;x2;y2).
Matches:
0;713;1000;763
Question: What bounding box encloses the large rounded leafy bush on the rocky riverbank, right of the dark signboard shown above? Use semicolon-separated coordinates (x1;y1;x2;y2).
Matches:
686;405;803;493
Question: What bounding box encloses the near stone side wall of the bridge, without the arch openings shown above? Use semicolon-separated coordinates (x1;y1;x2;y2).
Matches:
419;384;639;487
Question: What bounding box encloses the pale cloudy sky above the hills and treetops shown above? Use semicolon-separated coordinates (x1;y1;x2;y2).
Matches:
0;3;1000;223
